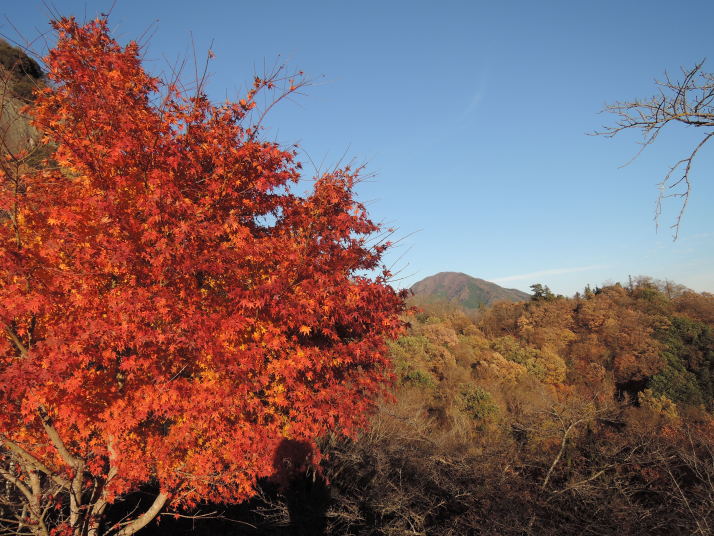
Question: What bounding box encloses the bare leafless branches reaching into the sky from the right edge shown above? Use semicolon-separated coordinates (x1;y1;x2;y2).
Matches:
595;60;714;240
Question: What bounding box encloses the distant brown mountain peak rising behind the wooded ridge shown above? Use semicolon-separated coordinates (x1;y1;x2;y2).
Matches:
411;272;531;309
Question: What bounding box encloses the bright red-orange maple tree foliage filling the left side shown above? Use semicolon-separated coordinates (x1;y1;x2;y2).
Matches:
0;19;404;534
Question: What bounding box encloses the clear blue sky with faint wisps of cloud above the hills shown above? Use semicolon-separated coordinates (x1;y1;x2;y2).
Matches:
0;0;714;295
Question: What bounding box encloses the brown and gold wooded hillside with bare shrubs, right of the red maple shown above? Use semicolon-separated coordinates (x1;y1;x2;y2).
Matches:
316;278;714;535
